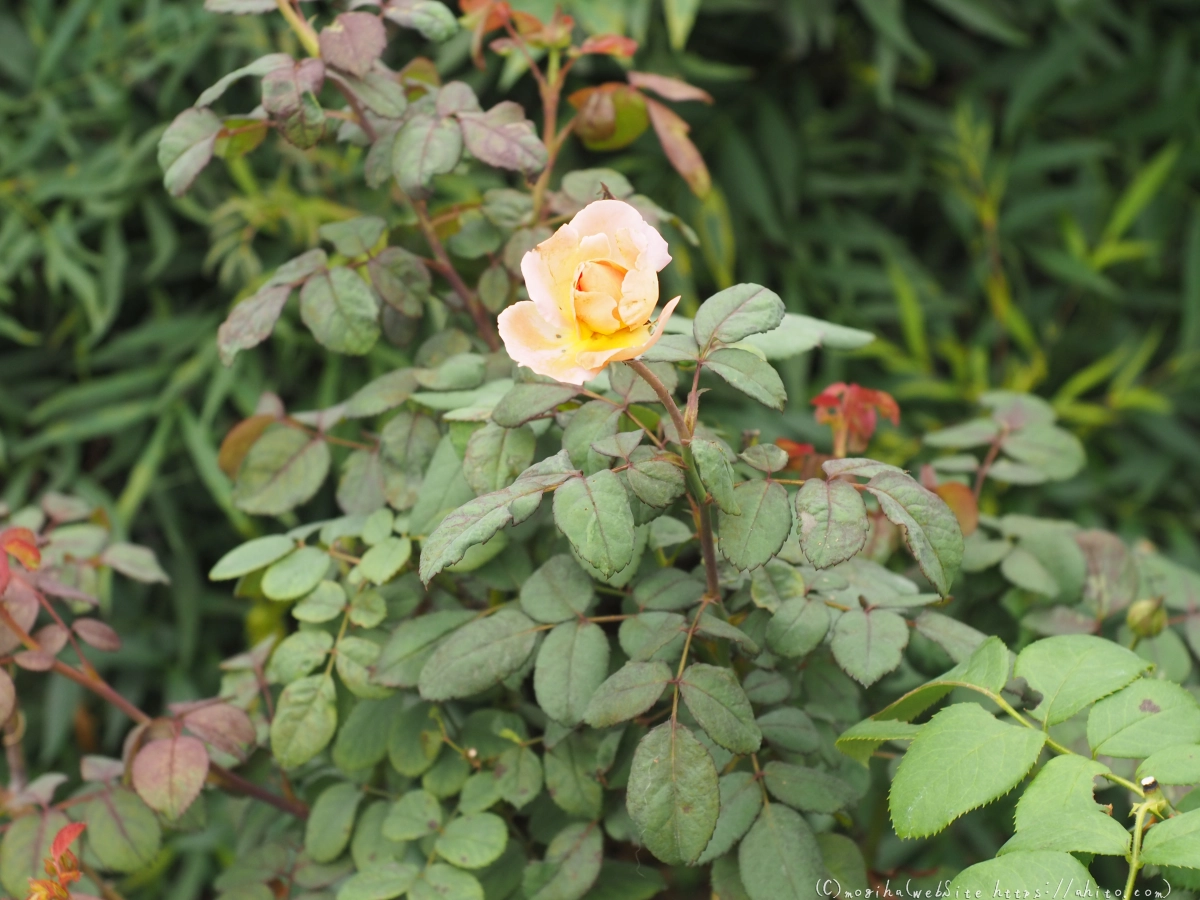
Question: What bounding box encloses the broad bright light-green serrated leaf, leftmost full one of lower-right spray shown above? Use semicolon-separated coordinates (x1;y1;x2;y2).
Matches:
888;703;1046;838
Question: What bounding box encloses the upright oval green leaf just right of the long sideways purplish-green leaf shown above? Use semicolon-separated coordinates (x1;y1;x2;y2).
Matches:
533;620;608;727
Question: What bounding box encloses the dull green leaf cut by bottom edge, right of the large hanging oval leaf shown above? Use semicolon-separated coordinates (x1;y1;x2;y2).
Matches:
738;803;824;900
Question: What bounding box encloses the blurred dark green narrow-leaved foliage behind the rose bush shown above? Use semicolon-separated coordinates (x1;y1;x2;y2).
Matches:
0;0;1200;900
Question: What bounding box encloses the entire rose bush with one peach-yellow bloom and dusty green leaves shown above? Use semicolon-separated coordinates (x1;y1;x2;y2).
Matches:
0;0;1200;900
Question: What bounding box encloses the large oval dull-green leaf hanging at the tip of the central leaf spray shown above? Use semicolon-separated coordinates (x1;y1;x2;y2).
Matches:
625;720;720;865
